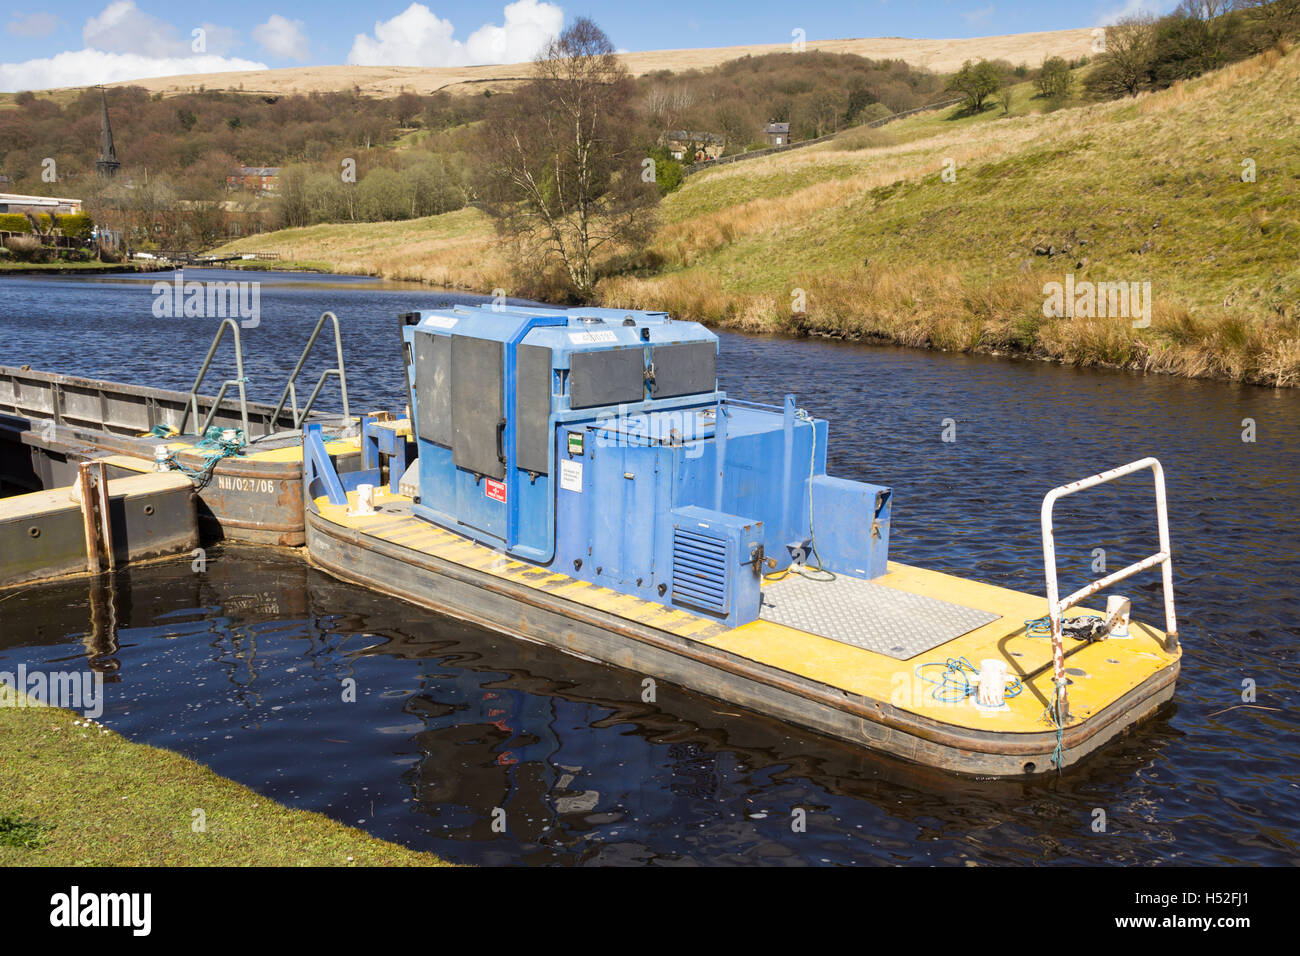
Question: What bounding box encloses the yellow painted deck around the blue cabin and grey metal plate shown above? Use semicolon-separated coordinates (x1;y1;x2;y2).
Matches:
316;489;1180;734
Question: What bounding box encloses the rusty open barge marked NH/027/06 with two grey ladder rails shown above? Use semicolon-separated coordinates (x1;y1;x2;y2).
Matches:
0;312;359;546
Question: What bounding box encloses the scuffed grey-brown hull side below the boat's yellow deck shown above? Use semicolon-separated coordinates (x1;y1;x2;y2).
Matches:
306;503;1179;778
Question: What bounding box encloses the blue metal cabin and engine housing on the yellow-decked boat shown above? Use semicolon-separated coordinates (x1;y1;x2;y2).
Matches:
306;307;891;627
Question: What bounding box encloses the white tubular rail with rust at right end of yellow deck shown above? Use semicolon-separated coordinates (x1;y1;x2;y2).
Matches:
1043;458;1178;721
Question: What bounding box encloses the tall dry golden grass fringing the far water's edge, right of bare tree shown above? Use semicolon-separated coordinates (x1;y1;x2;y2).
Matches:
601;265;1300;386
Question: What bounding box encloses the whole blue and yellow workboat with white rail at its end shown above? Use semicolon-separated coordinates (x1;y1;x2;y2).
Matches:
303;307;1182;777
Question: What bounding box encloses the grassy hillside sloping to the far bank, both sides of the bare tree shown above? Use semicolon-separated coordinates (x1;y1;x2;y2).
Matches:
210;51;1300;385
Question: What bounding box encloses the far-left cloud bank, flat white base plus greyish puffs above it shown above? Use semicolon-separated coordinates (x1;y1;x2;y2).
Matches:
0;0;267;91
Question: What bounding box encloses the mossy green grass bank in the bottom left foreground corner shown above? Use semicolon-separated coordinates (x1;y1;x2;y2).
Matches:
0;686;446;866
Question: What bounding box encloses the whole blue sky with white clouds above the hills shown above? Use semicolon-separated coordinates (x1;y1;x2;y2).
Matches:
0;0;1177;92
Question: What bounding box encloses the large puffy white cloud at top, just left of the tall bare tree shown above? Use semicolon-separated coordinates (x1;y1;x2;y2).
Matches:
347;0;564;66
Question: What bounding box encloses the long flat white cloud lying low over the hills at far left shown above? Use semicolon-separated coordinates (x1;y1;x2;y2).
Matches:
0;49;267;92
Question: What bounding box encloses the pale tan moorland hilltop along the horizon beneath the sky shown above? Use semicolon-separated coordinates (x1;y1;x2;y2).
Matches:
78;29;1092;96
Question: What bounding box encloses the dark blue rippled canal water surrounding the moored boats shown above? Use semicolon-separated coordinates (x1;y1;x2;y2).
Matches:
0;273;1300;865
